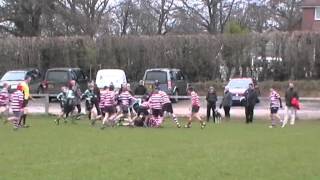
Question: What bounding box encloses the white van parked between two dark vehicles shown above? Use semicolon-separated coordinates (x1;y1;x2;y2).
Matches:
96;69;127;89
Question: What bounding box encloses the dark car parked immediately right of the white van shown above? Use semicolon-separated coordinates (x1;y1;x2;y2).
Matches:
143;68;188;102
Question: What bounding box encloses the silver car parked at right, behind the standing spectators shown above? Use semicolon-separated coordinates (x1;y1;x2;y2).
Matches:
227;78;260;105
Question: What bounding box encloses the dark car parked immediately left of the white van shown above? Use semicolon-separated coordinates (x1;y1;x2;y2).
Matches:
39;68;88;97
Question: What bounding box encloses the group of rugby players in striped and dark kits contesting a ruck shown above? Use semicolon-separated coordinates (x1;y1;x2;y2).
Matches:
55;82;206;129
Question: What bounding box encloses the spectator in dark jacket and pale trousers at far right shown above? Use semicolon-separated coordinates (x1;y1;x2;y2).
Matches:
282;83;299;128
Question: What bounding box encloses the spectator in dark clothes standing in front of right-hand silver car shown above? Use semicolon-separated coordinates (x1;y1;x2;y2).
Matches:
244;83;258;124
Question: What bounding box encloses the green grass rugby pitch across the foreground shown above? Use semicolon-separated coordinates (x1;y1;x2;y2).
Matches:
0;117;320;180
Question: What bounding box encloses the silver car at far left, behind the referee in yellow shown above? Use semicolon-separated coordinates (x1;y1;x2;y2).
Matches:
0;68;41;93
